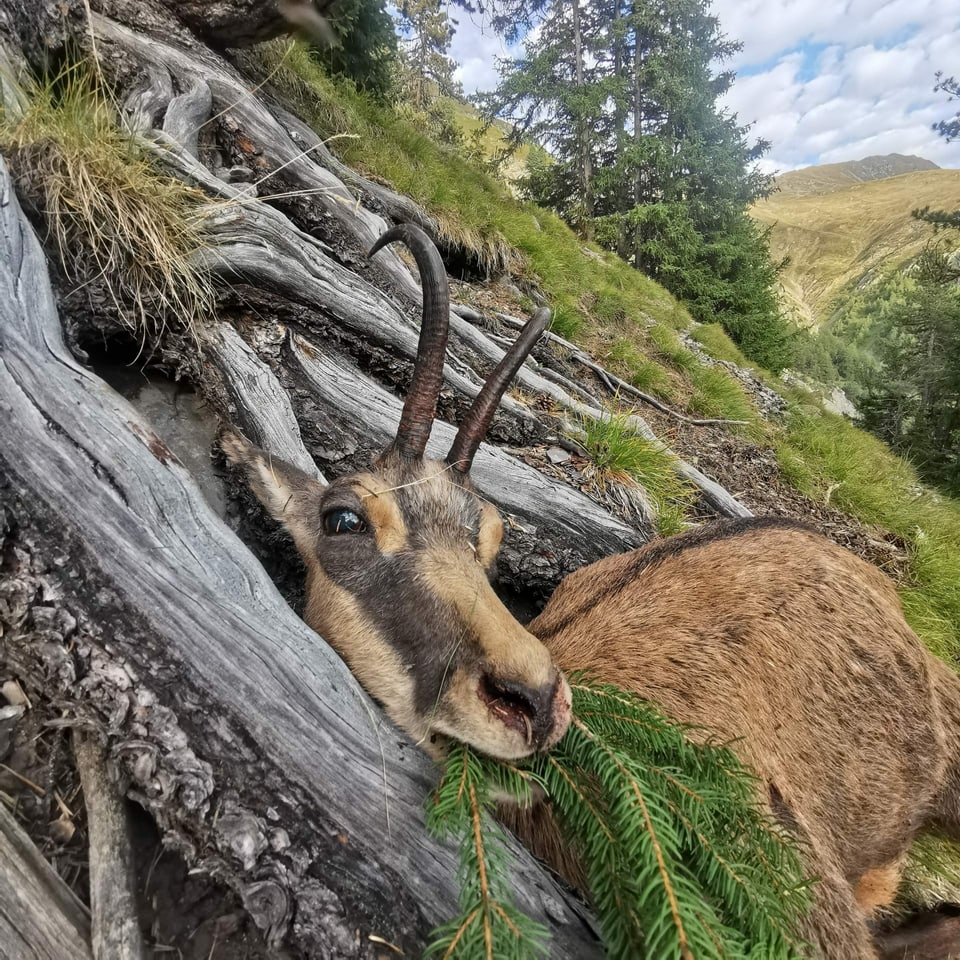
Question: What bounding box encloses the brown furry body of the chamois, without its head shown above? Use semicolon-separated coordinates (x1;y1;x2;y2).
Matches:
527;520;960;960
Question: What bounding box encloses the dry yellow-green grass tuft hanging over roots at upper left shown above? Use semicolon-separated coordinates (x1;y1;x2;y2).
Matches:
0;65;214;339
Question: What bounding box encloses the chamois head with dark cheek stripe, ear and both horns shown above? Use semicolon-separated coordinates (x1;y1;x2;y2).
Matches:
223;224;570;759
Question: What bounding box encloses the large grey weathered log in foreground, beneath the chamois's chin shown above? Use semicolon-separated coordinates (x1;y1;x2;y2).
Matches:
0;156;596;957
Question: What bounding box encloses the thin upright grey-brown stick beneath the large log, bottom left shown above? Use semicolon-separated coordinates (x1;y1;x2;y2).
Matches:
73;730;144;960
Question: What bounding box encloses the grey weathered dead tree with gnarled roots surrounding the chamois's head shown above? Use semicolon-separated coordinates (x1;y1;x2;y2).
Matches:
0;0;756;958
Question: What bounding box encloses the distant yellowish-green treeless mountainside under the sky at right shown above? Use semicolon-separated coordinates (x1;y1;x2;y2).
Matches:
751;163;960;327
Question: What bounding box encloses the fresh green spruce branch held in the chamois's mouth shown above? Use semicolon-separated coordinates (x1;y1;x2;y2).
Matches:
428;677;809;960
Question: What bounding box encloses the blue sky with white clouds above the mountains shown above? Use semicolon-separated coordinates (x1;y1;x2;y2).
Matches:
451;0;960;173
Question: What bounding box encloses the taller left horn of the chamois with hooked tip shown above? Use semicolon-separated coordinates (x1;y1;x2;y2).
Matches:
367;223;450;459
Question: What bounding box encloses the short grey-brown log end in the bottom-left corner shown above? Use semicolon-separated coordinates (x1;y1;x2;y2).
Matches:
0;803;93;960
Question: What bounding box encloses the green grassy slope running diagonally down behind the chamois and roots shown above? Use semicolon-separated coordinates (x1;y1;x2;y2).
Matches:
258;48;960;663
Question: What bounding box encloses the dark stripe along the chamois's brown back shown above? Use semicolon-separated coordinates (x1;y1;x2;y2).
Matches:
537;516;815;640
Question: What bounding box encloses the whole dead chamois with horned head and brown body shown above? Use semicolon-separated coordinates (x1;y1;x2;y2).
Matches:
223;224;960;960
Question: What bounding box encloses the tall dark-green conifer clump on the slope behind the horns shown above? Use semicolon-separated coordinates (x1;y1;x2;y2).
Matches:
480;0;790;369
